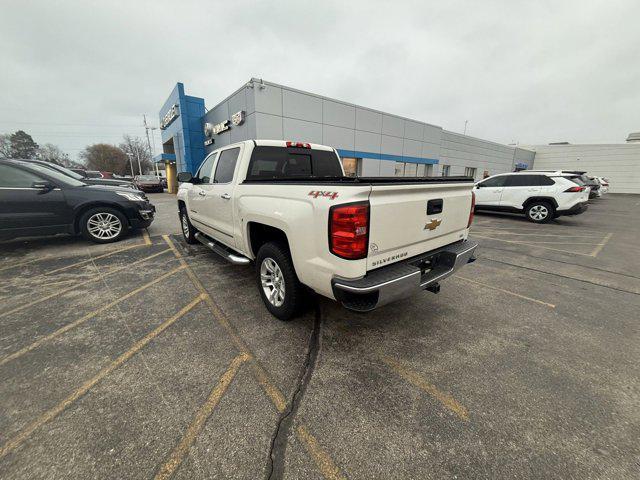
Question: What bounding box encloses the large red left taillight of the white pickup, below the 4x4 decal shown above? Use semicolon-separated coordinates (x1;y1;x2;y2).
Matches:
329;202;369;260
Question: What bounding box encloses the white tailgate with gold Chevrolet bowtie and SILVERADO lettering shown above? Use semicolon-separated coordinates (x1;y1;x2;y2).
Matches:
367;182;473;270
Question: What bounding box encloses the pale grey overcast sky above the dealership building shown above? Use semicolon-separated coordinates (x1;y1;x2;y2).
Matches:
0;0;640;161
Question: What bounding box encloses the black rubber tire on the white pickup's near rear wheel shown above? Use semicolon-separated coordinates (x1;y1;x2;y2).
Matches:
256;242;306;321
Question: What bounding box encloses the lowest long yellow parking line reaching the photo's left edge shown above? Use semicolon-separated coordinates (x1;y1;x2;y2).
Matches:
0;295;203;459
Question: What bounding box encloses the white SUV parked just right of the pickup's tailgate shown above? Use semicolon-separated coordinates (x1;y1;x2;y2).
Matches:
474;171;589;223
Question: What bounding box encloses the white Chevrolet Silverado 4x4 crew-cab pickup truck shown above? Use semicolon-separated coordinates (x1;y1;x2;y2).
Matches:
178;140;477;320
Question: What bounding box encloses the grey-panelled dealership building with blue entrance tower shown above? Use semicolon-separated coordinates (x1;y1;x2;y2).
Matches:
155;78;640;193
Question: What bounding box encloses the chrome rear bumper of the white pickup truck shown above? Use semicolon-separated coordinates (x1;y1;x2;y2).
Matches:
332;240;478;312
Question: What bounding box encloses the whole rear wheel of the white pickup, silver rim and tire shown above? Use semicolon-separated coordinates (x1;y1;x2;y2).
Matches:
256;242;305;320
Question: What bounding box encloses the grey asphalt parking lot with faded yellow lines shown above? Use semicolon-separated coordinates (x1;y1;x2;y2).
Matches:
0;195;640;479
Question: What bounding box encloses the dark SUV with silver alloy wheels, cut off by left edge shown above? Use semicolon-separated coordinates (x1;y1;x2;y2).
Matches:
0;160;155;243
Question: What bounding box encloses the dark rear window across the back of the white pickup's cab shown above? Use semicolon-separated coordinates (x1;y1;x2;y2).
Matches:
247;145;342;180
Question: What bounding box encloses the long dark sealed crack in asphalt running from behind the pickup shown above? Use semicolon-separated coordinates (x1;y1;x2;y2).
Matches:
267;304;322;480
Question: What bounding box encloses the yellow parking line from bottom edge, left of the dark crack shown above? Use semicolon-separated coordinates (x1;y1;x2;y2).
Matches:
155;353;250;480
